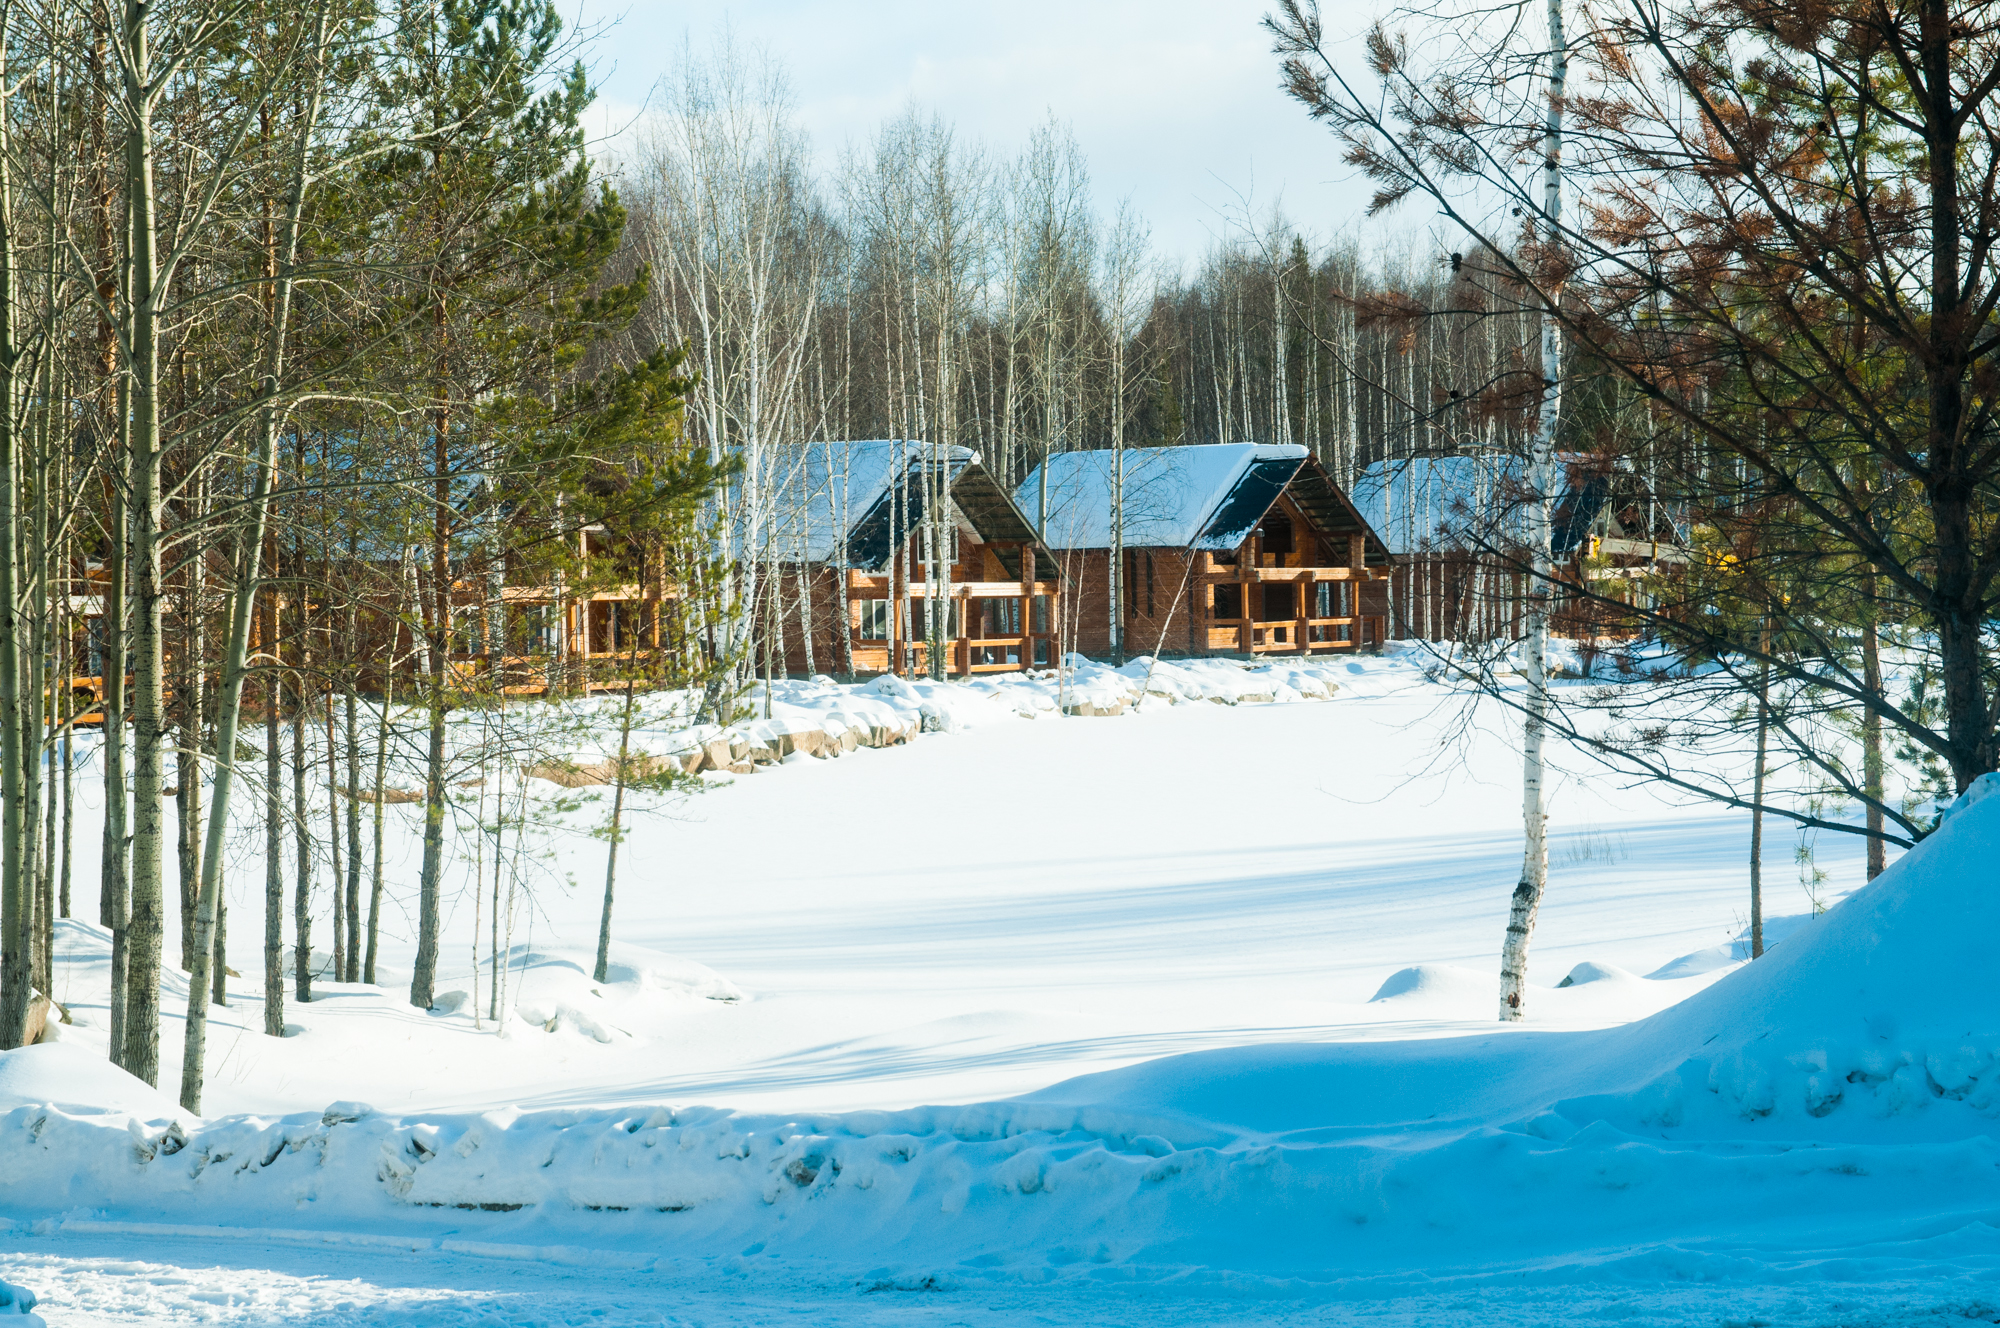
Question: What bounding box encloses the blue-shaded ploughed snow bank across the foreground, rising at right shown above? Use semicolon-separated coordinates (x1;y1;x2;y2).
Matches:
0;780;2000;1282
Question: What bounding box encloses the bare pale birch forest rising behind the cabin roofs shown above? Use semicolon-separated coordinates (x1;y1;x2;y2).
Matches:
616;42;1536;684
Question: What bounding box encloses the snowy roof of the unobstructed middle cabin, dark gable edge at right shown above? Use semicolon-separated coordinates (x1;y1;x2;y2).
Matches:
1014;442;1384;554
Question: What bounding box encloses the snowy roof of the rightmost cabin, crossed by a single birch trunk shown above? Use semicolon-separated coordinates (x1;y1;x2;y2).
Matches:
1354;452;1610;558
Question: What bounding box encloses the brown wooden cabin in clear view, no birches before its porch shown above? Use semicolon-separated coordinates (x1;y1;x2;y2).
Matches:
1014;442;1390;656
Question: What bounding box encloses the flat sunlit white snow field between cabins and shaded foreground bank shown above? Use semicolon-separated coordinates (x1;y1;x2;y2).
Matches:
19;656;1816;1114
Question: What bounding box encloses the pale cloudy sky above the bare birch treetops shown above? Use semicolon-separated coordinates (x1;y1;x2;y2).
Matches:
562;0;1414;266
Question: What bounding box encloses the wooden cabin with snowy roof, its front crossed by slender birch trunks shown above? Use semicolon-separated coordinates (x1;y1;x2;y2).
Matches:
756;438;1062;676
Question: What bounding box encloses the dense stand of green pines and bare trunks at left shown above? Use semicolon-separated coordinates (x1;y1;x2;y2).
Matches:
0;0;726;1110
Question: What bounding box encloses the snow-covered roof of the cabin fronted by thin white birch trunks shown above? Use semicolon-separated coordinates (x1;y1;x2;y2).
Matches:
756;438;1034;570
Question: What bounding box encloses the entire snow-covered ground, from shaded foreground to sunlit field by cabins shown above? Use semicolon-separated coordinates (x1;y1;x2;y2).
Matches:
0;656;2000;1326
